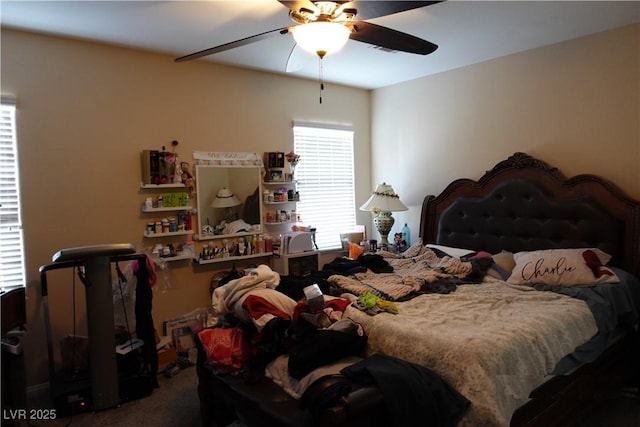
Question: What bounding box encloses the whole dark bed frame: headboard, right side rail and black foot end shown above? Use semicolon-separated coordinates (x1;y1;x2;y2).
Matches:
198;153;640;427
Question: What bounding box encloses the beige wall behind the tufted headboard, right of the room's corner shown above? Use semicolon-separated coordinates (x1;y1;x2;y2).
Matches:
371;25;640;236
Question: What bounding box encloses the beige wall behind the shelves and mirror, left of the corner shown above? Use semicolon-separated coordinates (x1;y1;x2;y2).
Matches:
1;29;370;385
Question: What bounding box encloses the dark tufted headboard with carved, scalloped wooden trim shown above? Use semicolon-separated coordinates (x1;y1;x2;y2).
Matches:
420;153;640;276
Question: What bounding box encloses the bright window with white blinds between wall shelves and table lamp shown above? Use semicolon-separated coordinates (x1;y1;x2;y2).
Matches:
293;123;356;250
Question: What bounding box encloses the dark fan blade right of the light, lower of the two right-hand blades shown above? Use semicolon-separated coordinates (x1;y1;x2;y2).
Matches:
348;21;438;55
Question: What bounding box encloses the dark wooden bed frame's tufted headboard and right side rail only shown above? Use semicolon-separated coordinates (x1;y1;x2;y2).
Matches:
420;153;640;426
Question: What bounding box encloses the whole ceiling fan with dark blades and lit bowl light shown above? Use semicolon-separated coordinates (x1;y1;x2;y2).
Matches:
175;0;440;62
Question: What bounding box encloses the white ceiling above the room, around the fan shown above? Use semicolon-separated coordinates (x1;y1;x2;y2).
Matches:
0;0;640;89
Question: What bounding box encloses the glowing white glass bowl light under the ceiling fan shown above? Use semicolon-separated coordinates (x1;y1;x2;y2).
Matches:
292;22;351;56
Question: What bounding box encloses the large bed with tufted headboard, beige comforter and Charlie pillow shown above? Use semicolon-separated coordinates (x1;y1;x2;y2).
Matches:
198;153;640;426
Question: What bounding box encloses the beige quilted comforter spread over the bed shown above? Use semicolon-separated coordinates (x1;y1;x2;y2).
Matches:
345;278;596;426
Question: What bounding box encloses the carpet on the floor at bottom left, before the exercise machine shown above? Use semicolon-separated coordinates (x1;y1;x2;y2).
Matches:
22;366;201;427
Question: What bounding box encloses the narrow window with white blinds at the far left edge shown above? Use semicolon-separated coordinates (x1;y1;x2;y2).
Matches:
0;98;25;290
